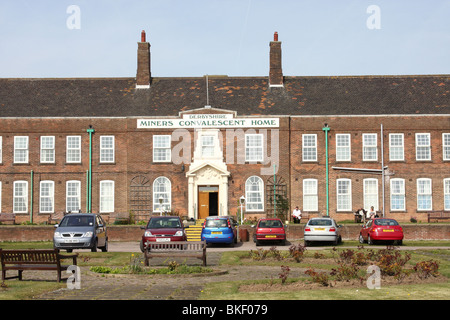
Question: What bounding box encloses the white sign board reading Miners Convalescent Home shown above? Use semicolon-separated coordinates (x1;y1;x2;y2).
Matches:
137;115;280;129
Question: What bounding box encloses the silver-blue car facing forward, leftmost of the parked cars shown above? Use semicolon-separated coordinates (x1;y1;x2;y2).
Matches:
53;213;108;252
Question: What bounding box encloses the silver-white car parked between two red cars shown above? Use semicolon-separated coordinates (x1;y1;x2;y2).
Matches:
304;217;342;246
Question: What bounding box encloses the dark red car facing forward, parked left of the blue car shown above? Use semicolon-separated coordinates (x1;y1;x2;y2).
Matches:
140;216;186;252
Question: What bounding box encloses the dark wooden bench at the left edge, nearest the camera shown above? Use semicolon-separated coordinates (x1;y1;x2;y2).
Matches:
0;249;78;282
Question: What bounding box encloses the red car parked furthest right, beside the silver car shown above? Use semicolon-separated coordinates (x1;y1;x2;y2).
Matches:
359;218;403;245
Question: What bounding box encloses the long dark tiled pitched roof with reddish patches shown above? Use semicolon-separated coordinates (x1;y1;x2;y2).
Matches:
0;75;450;117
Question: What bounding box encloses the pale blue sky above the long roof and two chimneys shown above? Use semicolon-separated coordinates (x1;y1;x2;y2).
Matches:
0;0;450;78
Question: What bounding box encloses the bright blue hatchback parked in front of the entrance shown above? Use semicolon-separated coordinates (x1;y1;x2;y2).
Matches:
201;216;237;246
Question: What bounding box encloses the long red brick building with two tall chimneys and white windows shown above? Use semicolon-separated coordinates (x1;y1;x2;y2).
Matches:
0;33;450;222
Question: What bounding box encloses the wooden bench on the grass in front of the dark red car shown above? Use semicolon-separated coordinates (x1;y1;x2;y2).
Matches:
144;241;206;267
